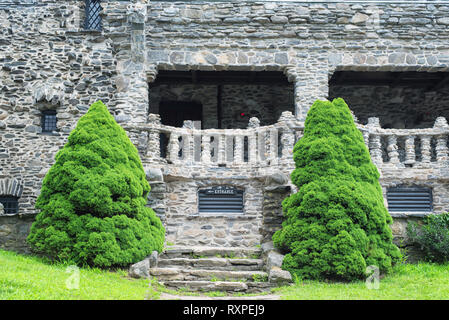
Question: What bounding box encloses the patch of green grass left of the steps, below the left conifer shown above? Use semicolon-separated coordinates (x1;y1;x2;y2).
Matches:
0;250;158;300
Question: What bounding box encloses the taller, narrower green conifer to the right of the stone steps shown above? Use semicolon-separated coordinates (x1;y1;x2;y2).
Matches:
273;98;400;280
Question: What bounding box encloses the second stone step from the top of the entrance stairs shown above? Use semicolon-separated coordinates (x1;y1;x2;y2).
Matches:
158;258;263;271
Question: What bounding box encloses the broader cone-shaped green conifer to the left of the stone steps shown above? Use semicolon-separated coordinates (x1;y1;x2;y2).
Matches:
28;101;165;267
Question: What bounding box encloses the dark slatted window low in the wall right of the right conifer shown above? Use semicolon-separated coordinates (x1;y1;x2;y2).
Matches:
387;187;433;212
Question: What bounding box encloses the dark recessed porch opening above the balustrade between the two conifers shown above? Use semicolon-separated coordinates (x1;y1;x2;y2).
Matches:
149;70;294;129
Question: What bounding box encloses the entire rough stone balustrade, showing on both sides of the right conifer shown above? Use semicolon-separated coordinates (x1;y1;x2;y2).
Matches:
123;111;449;169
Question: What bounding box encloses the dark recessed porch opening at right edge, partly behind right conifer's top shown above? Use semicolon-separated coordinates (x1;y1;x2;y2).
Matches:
329;71;449;129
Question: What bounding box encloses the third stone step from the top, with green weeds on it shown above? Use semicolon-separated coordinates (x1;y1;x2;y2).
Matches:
150;267;268;282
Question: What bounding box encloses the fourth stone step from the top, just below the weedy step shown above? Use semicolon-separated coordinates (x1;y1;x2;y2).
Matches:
161;280;274;293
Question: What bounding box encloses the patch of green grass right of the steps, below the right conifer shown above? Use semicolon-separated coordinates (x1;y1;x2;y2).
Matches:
275;263;449;300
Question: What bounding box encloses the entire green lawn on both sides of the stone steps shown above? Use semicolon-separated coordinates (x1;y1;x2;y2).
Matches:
0;250;449;300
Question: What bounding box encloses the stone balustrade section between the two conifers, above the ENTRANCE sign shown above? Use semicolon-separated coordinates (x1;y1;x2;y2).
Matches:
133;112;302;167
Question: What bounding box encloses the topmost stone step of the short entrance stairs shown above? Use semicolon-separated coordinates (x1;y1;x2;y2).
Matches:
160;246;262;259
